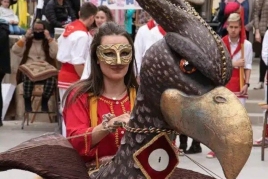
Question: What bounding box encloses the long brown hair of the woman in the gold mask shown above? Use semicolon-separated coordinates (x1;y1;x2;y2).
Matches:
63;22;138;105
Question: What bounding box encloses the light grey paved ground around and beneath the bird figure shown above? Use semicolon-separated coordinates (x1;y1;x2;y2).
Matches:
0;59;268;179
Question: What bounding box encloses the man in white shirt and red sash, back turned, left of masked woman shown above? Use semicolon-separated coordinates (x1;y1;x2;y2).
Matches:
57;2;97;136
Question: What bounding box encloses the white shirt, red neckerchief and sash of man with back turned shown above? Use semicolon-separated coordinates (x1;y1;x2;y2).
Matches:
57;20;92;136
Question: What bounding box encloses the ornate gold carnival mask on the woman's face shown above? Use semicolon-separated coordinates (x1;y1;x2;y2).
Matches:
97;44;132;65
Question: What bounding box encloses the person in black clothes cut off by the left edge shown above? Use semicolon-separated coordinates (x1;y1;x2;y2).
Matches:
0;22;11;127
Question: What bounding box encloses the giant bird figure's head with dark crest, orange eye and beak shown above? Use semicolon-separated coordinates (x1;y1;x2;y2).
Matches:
137;0;252;179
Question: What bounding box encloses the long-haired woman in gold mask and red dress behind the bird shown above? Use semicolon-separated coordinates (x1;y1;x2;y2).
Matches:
63;22;138;165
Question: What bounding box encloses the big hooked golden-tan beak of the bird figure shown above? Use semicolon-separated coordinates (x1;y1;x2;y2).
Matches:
160;87;252;179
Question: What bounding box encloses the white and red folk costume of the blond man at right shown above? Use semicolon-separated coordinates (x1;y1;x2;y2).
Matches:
223;7;253;105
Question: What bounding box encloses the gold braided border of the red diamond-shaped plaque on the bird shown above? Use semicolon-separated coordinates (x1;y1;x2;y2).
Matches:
133;132;179;179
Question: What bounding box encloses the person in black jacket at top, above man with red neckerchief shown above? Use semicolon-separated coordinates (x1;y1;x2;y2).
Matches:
44;0;76;36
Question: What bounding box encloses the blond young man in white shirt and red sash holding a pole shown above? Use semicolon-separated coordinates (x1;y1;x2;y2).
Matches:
207;13;253;158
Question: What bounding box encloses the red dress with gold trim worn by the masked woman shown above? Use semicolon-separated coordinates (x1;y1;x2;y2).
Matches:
63;94;131;162
